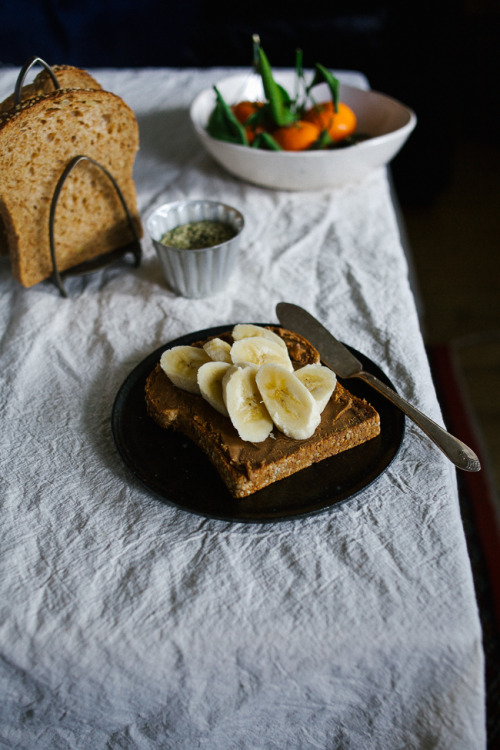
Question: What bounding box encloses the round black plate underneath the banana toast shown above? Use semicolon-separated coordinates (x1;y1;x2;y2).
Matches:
112;324;404;522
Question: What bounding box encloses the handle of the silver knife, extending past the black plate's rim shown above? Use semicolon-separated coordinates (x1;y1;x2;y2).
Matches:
354;370;481;471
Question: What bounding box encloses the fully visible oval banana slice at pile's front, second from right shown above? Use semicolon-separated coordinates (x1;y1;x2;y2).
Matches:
255;363;321;440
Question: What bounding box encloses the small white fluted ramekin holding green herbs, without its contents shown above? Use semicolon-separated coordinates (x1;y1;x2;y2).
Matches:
147;200;245;298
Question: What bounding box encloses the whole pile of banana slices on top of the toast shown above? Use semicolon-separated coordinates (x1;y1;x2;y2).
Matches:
160;323;337;443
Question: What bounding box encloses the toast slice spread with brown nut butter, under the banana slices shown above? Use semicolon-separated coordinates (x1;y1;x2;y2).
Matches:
145;326;380;498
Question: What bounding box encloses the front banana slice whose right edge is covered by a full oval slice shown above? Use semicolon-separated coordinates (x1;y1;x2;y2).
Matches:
222;366;273;443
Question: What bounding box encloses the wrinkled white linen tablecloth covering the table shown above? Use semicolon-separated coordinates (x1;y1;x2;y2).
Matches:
0;69;485;750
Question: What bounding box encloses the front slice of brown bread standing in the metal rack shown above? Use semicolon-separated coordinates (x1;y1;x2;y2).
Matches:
0;89;142;287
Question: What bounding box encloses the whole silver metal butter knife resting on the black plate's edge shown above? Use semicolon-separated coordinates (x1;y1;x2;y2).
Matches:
276;302;481;471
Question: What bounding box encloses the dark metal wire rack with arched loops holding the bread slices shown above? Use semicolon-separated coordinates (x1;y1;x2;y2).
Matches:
14;57;142;297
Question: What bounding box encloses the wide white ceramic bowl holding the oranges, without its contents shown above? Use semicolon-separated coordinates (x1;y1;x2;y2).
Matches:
190;71;417;190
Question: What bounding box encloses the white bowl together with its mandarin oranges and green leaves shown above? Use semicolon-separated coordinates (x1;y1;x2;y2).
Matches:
190;37;417;191
